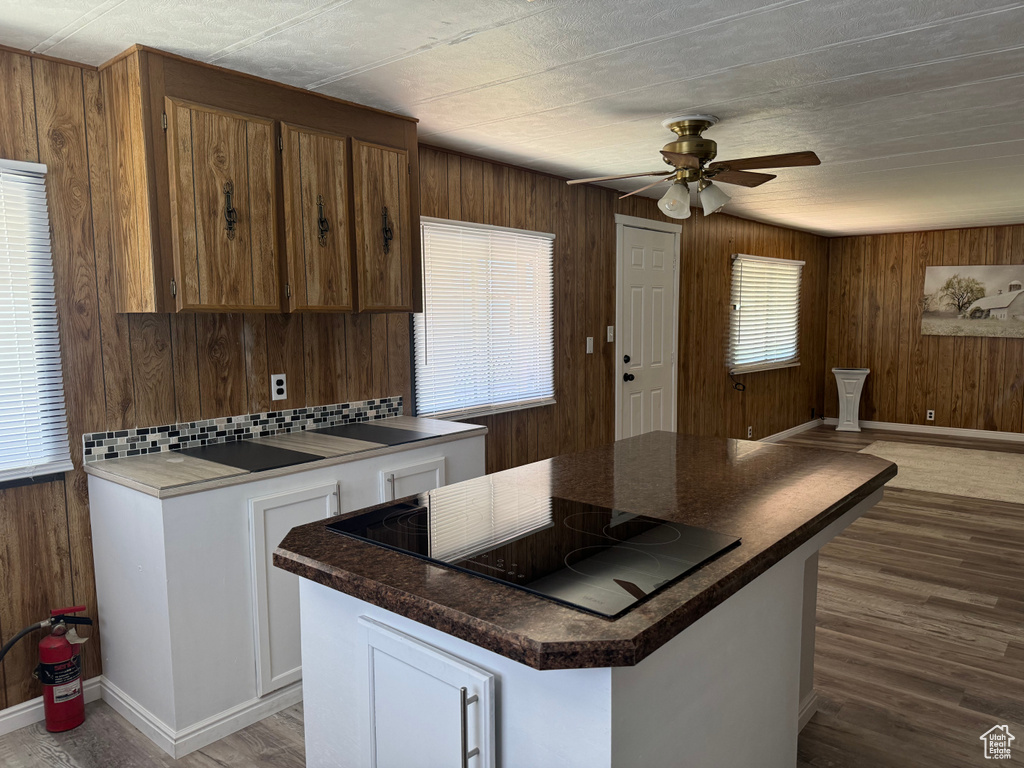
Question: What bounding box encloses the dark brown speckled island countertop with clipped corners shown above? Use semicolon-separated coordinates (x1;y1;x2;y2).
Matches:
273;432;896;670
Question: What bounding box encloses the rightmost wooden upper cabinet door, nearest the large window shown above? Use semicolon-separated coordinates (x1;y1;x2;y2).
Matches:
352;141;413;312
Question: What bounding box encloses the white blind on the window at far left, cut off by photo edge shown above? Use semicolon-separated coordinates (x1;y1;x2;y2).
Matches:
0;160;72;481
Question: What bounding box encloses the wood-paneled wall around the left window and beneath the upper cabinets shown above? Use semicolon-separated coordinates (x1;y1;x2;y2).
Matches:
0;50;410;709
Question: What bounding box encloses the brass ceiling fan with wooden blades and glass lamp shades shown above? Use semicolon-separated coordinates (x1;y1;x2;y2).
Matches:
568;115;821;219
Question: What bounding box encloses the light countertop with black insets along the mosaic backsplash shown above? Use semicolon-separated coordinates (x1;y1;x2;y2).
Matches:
85;416;487;499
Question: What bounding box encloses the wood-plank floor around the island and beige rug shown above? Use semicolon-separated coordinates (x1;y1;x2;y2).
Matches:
0;426;1024;768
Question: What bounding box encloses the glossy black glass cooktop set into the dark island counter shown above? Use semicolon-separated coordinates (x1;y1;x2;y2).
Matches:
327;487;739;618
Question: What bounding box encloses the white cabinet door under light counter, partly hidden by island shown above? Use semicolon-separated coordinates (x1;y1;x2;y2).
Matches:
249;483;338;696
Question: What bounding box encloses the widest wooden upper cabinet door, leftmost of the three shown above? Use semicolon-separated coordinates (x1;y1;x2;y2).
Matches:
167;99;281;310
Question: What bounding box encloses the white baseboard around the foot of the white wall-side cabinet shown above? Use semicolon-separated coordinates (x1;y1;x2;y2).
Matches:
102;678;302;760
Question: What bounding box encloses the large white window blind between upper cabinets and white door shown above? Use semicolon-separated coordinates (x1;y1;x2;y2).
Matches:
413;218;554;418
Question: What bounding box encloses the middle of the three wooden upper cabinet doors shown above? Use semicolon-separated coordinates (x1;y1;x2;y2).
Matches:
282;125;352;311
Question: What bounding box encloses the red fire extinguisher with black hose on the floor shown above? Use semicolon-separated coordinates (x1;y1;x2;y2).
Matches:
0;605;92;733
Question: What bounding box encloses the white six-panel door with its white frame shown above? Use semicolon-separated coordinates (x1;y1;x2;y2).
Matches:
615;214;682;440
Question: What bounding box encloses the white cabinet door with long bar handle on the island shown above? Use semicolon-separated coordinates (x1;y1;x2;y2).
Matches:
359;616;495;768
